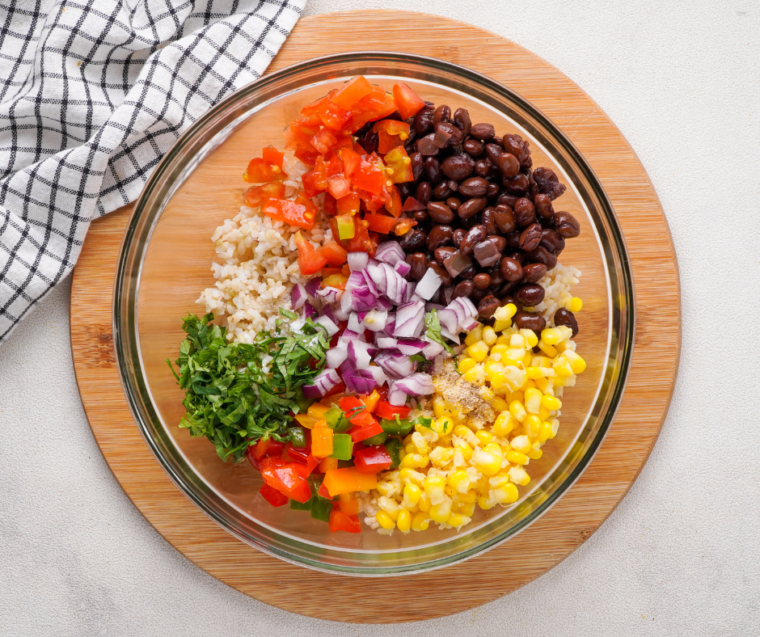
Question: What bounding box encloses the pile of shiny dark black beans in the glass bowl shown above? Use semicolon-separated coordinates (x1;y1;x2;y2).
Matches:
359;102;580;333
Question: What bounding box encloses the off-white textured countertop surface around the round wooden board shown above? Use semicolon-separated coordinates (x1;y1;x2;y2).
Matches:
0;0;760;637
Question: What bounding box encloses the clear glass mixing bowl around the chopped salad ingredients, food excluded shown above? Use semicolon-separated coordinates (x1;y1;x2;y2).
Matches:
114;53;634;576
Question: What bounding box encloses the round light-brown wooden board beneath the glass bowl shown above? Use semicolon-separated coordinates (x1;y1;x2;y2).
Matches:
71;11;681;623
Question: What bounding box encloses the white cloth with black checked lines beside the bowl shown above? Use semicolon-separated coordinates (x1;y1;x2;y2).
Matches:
0;0;306;342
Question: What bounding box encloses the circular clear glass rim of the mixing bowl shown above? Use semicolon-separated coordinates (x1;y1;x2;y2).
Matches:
112;51;636;577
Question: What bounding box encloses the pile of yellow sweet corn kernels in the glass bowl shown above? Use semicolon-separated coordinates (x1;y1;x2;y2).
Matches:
363;297;586;534
